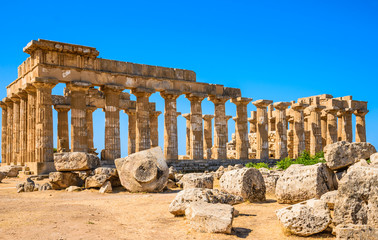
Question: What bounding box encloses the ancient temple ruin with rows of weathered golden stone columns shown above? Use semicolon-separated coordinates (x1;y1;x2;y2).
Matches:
0;39;368;173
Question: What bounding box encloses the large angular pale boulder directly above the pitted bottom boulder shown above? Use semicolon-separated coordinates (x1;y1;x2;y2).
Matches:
276;163;337;204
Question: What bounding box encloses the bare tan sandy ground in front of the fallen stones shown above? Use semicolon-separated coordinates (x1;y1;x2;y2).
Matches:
0;178;334;240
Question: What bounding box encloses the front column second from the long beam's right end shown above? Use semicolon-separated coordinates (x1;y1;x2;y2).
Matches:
205;96;229;159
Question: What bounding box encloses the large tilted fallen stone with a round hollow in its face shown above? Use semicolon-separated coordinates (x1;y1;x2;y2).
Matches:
114;147;169;192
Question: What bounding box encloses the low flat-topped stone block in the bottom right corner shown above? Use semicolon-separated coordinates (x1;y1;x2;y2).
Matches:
335;224;378;240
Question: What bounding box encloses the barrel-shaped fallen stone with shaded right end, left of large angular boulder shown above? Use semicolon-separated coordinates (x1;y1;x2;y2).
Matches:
219;168;266;202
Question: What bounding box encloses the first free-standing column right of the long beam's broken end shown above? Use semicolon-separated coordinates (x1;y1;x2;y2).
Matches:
253;100;273;159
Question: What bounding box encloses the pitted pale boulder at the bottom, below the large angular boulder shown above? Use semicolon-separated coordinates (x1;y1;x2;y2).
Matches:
276;199;332;236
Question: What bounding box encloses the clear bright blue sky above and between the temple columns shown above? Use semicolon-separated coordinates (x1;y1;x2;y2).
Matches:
0;0;378;159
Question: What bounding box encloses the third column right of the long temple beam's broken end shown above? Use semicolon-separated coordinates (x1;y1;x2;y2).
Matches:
291;103;306;158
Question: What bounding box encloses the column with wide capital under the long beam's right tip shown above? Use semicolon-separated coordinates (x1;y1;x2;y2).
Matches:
231;97;252;159
